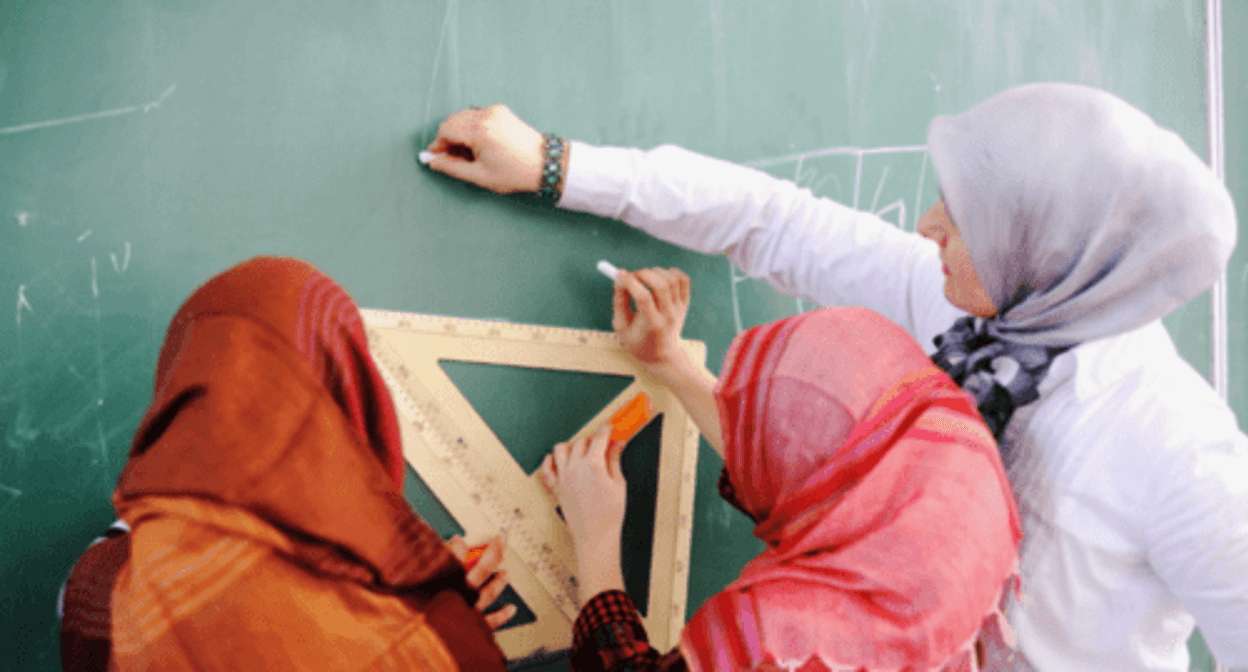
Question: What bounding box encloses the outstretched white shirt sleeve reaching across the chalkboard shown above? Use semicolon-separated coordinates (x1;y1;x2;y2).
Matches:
559;142;966;352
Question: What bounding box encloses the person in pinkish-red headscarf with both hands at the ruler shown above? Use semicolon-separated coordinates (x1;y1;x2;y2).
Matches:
542;263;1021;671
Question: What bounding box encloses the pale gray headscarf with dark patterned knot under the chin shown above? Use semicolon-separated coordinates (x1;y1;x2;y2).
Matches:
927;84;1237;436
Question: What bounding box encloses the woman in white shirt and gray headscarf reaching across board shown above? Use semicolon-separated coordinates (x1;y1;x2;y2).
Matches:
429;84;1248;672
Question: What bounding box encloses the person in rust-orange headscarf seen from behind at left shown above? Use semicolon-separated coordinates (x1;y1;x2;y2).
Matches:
61;257;512;672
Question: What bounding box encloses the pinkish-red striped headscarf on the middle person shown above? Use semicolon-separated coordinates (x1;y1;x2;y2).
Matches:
680;309;1022;671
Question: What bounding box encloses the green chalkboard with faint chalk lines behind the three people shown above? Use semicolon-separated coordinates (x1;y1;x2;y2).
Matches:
0;0;1223;670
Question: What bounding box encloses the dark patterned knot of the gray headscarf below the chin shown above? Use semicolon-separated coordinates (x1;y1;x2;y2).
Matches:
932;317;1070;442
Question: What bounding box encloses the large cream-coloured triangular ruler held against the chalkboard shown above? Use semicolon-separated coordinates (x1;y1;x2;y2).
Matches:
361;310;706;660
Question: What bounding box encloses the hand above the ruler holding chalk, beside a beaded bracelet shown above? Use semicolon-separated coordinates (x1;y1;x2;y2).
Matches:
421;105;543;194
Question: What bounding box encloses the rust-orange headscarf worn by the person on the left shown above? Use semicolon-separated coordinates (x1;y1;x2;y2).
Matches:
103;257;504;670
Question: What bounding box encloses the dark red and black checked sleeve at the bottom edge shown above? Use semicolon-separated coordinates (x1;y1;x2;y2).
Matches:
568;591;686;672
